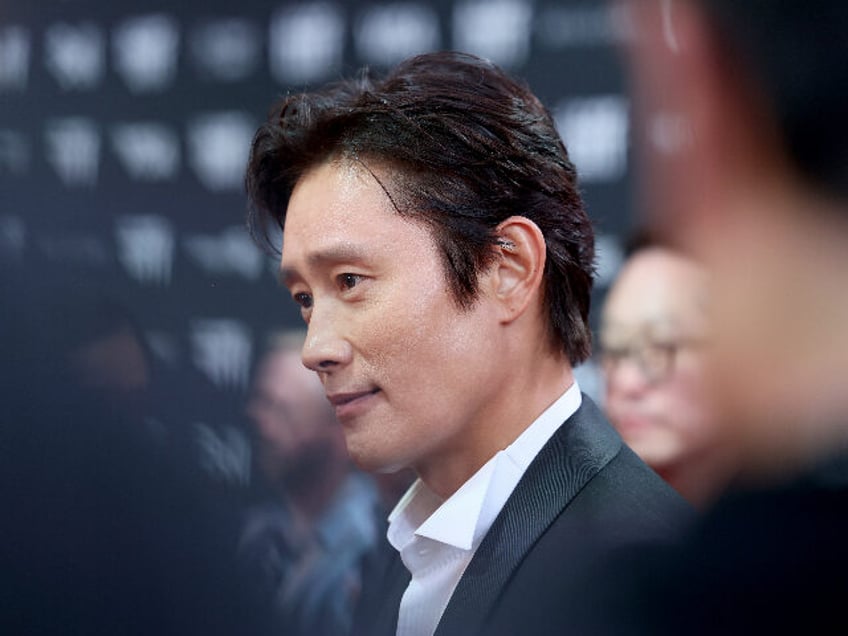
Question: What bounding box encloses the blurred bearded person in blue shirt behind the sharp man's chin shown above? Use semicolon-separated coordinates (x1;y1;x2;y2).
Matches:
239;332;383;636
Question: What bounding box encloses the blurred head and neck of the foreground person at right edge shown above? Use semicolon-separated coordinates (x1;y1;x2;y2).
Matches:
623;0;848;472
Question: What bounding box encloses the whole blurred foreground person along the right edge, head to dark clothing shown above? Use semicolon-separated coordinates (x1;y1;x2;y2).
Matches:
616;0;848;634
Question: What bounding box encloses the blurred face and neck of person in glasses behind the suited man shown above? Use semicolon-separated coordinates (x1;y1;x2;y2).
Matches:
600;238;732;508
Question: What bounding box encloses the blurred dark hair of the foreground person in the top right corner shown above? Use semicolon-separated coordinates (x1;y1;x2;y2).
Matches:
700;0;848;197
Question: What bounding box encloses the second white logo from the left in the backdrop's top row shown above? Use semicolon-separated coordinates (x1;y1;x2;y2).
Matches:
44;22;106;91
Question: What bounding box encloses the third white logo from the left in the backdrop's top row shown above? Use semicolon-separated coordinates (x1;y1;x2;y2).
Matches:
112;14;180;93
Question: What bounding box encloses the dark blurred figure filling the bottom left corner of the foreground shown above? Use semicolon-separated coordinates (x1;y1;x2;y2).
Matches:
0;268;258;636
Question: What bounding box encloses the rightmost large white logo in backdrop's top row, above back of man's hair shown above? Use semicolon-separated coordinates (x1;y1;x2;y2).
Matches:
453;0;533;67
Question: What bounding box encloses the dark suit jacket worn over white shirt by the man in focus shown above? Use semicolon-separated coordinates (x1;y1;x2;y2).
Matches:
354;395;692;636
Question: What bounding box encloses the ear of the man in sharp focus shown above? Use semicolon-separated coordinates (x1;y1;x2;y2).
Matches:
490;216;547;322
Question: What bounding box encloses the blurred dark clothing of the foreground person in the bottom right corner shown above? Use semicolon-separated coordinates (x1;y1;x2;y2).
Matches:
593;449;848;636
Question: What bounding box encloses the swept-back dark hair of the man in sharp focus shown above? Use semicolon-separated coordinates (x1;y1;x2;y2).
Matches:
246;52;594;364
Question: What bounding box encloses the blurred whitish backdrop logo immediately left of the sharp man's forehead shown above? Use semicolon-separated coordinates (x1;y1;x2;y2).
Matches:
185;226;265;280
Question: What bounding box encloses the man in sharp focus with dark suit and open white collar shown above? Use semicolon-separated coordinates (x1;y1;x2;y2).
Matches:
247;53;688;635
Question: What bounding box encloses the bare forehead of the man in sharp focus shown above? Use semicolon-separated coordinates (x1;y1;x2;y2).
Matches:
281;160;432;278
